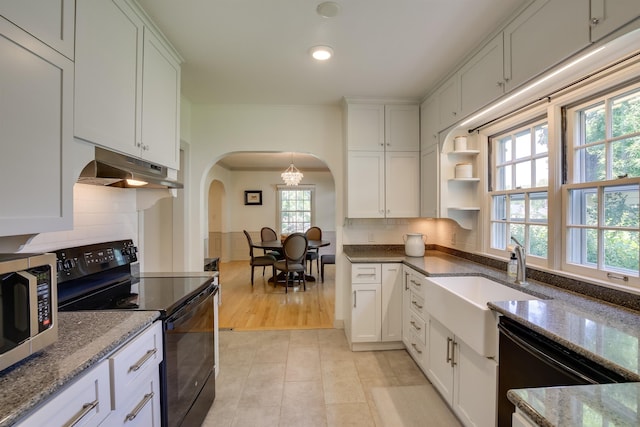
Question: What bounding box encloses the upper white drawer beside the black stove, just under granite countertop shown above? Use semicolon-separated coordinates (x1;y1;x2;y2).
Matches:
109;322;162;409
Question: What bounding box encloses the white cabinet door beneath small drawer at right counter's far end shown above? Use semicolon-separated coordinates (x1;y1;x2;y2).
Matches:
351;283;382;342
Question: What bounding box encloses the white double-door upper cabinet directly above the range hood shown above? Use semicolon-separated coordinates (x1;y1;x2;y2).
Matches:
75;0;180;169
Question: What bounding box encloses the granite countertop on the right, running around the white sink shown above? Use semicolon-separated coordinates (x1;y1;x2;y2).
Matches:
344;246;640;427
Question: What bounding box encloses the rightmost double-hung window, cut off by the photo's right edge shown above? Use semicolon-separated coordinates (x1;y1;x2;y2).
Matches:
563;85;640;284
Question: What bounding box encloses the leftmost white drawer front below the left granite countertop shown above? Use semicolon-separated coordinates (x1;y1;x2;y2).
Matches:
18;361;111;427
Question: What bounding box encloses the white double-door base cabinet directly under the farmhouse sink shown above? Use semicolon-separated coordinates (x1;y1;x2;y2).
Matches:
427;317;498;427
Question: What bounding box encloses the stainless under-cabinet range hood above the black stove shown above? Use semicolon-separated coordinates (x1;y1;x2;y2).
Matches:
78;147;183;188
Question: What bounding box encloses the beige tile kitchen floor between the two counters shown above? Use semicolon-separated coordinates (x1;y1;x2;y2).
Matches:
203;329;456;427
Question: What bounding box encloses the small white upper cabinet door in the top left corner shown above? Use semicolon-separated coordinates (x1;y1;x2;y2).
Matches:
0;0;75;60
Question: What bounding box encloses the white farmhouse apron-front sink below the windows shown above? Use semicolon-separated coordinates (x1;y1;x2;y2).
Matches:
425;276;538;357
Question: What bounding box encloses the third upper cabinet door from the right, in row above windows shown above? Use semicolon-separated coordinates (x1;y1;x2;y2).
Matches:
460;33;504;116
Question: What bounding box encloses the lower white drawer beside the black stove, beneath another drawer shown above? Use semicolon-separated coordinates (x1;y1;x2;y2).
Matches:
109;370;161;427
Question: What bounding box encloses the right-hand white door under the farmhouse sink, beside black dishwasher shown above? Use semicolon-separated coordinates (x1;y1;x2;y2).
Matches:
453;338;498;426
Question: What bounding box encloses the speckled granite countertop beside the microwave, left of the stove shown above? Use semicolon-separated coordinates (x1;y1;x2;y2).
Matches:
0;311;159;427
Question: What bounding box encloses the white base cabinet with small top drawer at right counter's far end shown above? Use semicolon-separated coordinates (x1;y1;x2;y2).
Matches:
347;263;402;350
